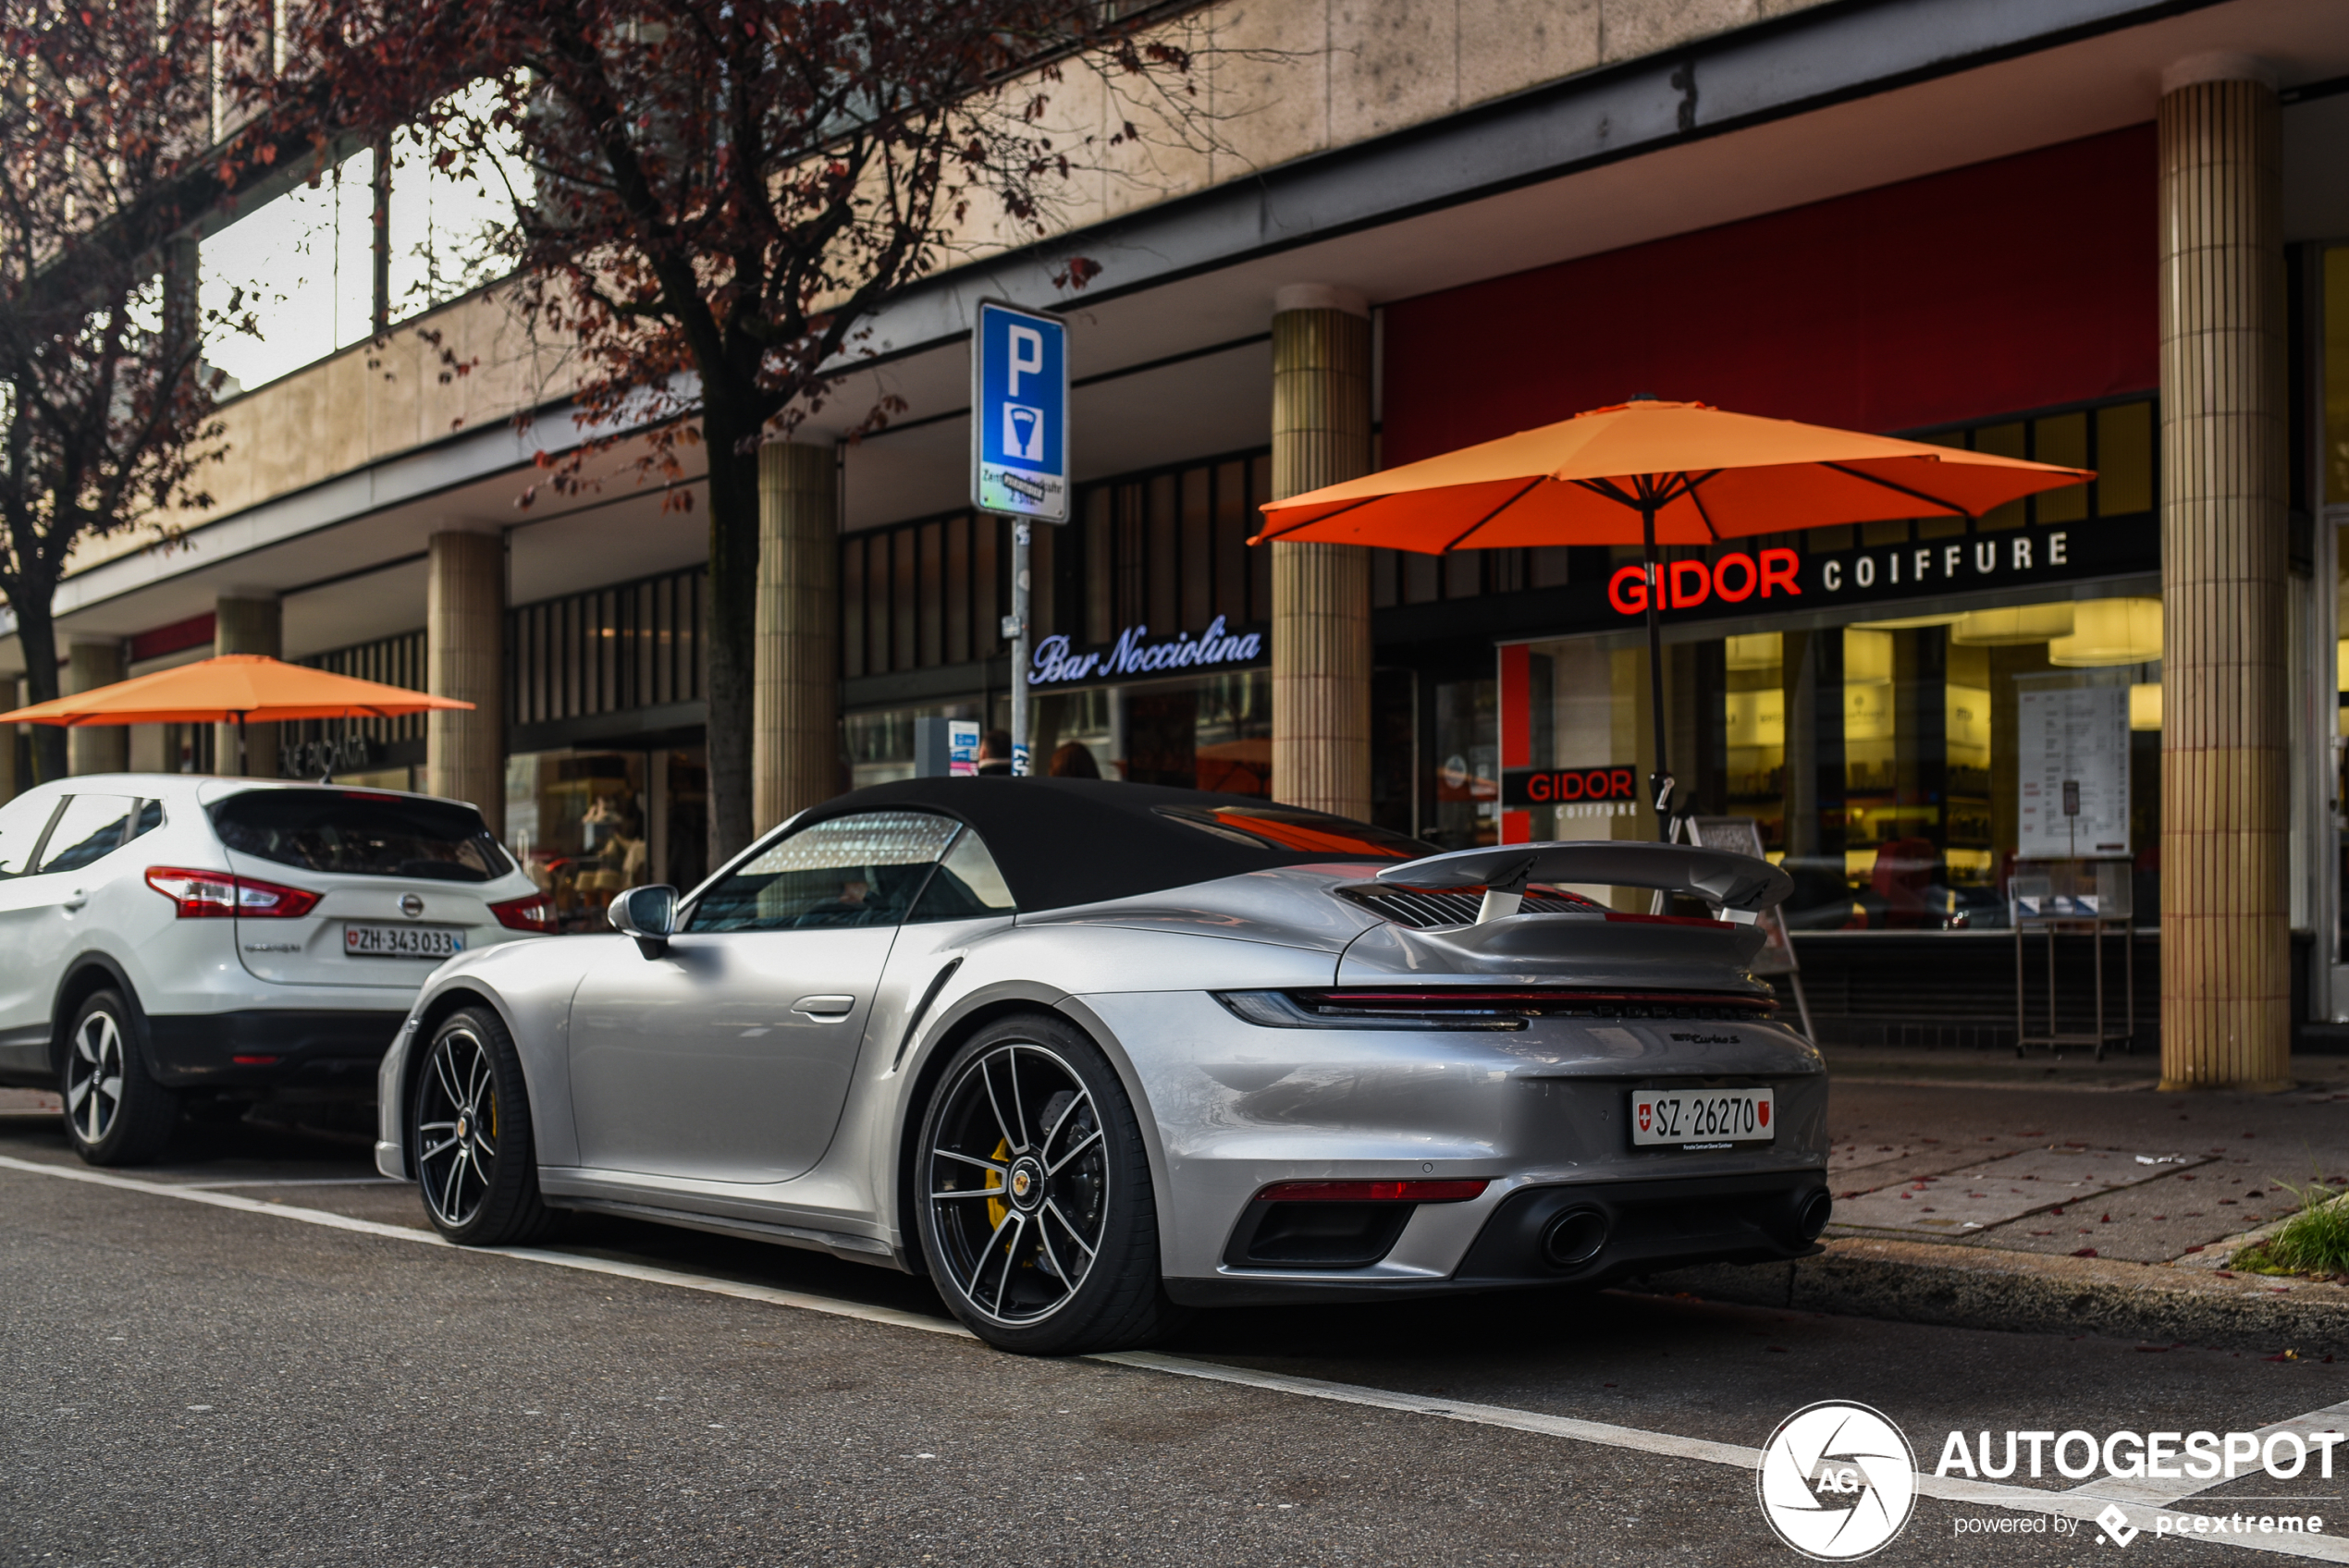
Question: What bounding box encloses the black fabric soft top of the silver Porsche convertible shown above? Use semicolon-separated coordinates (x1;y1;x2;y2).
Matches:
794;777;1435;911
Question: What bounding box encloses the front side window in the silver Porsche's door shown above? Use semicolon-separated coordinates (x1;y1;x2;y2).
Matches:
686;812;961;932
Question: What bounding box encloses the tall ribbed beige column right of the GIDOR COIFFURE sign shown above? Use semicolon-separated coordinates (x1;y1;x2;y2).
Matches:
2158;56;2291;1089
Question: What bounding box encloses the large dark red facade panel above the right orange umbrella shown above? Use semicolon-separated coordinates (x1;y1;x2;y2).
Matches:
1382;125;2158;465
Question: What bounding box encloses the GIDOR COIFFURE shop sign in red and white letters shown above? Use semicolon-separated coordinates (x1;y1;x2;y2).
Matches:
1588;519;2161;627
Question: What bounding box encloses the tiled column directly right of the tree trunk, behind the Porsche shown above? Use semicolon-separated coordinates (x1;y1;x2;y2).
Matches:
749;441;841;833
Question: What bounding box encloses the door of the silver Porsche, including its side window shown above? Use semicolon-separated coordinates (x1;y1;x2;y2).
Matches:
571;812;958;1183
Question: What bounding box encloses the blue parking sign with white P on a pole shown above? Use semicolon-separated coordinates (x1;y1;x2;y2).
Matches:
970;300;1069;523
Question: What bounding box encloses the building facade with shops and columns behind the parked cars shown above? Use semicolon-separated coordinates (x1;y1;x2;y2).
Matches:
12;0;2349;1087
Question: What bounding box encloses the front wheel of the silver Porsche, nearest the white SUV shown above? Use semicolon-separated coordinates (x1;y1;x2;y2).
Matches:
409;1007;554;1246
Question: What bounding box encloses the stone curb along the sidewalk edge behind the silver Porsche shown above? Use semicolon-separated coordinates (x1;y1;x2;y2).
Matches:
1623;1237;2349;1356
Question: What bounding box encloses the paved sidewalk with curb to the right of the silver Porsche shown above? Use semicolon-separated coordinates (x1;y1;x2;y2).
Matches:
1647;1049;2349;1354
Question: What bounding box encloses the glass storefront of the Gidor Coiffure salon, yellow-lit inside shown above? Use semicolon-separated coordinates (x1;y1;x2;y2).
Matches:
1513;596;2161;929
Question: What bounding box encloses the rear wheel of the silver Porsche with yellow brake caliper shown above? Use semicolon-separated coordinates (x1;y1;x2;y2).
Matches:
914;1014;1179;1354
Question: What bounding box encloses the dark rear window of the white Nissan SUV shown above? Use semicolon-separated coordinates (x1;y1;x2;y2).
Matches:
212;789;514;883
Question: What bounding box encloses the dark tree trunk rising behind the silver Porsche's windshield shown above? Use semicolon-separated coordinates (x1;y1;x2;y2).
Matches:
702;410;758;868
